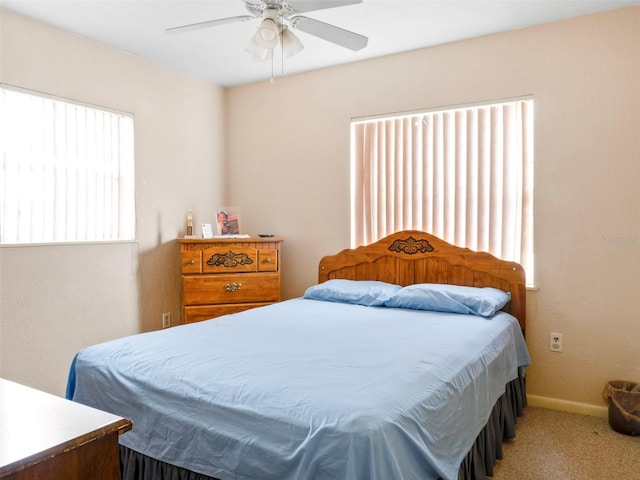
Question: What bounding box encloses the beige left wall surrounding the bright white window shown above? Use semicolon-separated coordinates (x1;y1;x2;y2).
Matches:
0;10;224;394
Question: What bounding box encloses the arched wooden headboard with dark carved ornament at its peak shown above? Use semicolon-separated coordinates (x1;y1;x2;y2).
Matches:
318;230;526;333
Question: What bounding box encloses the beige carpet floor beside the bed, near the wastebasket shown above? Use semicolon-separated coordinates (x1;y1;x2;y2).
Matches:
492;407;640;480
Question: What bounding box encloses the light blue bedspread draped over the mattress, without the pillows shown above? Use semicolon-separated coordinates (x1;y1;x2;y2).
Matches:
68;298;529;480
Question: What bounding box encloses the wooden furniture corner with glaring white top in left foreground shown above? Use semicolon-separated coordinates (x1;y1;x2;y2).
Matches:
0;379;132;480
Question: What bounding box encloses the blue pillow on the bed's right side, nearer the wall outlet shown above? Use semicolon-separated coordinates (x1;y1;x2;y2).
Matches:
385;283;511;317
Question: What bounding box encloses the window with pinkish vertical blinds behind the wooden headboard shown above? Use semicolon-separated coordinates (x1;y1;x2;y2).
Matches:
351;99;533;284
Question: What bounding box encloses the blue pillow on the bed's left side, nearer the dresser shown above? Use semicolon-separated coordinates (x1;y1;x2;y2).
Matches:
304;279;402;307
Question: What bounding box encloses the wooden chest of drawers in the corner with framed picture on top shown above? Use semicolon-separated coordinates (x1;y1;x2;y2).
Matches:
178;237;283;323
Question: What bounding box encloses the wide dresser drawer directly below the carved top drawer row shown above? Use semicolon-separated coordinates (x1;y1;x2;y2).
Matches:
182;273;280;305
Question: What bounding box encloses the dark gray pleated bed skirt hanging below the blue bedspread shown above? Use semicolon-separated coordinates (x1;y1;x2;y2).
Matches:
120;368;527;480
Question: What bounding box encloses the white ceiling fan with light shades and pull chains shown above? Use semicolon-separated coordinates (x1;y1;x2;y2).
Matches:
165;0;369;60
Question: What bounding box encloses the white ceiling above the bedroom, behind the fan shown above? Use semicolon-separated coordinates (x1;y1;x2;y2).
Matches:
0;0;640;87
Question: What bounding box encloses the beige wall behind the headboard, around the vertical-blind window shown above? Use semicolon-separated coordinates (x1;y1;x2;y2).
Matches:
227;8;640;414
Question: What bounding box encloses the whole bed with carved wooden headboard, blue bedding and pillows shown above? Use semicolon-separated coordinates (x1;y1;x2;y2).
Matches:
67;231;530;480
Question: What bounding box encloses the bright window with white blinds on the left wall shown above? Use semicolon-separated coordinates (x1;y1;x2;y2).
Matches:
0;86;135;244
